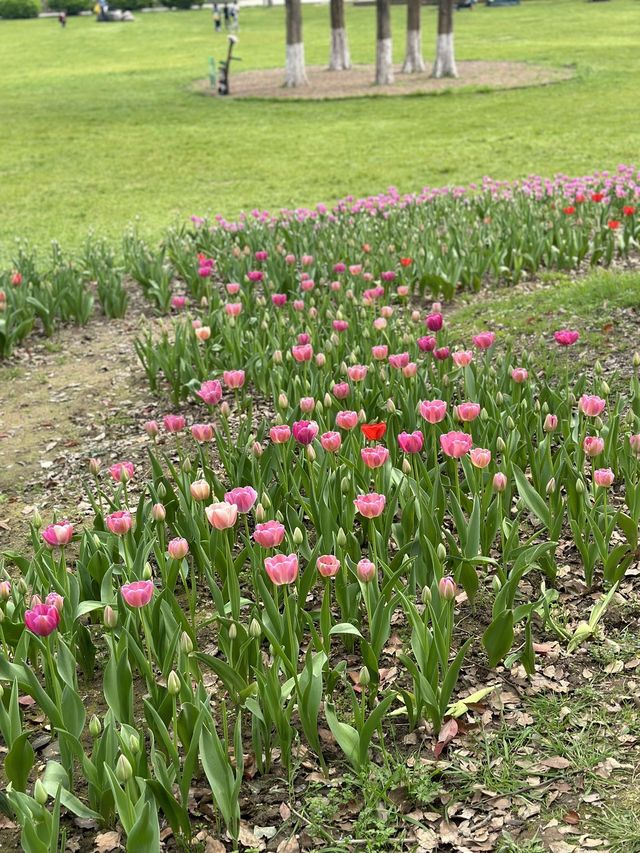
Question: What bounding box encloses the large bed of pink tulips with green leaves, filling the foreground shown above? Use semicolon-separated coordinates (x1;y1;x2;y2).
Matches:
0;172;640;853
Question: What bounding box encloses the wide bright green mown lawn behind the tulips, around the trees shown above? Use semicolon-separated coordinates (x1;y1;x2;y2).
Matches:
0;0;640;253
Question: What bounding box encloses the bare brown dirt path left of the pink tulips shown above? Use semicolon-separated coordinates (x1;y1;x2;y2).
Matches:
0;300;155;550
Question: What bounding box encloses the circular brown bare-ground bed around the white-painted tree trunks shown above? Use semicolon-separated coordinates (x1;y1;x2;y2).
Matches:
197;61;573;100
